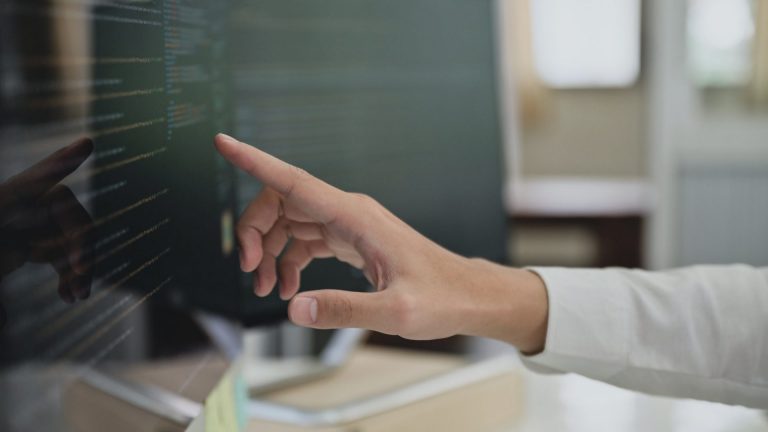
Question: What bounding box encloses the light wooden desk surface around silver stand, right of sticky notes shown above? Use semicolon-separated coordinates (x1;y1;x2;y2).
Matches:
234;347;521;432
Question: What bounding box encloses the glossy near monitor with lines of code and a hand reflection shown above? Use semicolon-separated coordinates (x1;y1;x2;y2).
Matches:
0;0;240;431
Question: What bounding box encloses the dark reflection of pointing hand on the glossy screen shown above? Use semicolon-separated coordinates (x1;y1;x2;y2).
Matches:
0;139;93;313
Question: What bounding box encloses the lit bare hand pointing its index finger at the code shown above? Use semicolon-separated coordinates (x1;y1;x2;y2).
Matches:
216;135;547;351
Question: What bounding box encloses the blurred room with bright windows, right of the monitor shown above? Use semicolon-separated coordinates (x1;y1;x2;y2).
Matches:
501;0;768;268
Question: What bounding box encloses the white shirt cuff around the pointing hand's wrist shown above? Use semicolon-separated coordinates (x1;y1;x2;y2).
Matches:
522;267;630;379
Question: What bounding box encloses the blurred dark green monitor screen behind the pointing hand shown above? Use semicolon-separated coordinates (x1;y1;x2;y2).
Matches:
225;0;506;323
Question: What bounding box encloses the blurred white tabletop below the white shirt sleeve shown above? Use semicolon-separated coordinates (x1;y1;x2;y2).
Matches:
471;339;768;432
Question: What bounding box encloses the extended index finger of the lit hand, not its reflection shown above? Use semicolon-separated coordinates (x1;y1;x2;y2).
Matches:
215;134;341;223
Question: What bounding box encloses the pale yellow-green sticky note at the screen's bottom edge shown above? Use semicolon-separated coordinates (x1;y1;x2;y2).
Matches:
205;366;247;432
